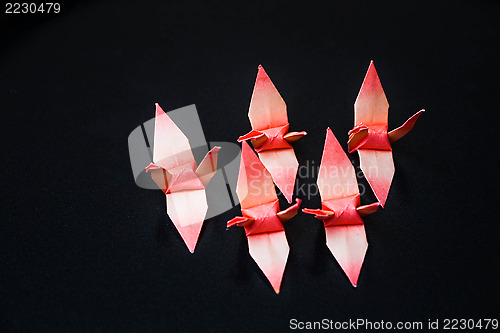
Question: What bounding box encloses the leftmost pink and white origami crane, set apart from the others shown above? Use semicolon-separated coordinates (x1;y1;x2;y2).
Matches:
146;103;220;253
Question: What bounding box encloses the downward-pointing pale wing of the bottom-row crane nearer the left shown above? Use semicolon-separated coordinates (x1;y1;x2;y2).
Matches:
248;231;290;294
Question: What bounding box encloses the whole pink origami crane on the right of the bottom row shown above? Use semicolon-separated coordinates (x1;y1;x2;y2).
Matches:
302;128;378;287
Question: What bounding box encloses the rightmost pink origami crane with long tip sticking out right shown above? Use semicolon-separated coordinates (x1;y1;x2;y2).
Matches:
348;61;424;207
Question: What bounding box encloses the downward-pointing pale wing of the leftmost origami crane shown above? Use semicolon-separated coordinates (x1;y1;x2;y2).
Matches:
167;189;208;253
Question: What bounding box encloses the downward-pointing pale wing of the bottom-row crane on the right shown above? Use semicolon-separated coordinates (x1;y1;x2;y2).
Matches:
325;224;368;287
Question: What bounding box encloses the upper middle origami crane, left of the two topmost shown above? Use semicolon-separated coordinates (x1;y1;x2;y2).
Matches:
238;66;307;203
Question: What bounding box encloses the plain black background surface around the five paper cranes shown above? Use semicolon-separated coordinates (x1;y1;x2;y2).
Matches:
0;1;499;332
